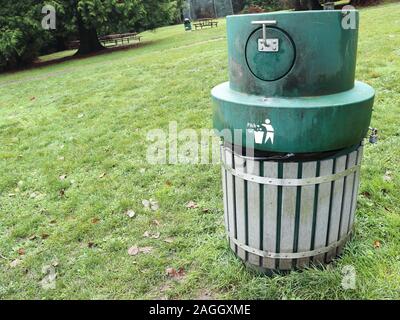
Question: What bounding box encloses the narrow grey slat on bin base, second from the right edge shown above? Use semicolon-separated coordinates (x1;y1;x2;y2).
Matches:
337;151;357;255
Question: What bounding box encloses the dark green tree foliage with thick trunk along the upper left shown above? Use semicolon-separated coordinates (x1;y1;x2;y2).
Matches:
0;0;183;71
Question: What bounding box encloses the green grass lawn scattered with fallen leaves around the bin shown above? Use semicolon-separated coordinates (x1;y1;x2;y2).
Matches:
0;3;400;299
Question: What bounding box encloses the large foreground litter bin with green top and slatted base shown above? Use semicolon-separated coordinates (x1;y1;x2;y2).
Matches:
212;10;375;273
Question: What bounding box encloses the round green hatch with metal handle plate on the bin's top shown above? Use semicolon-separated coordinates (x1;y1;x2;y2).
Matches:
246;27;296;81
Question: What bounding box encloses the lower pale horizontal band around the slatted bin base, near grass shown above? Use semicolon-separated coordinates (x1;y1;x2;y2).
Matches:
228;232;352;260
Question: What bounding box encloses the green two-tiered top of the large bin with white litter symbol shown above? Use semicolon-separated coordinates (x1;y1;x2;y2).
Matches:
212;11;375;153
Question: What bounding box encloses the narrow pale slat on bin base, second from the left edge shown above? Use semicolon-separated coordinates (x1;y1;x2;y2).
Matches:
234;155;247;260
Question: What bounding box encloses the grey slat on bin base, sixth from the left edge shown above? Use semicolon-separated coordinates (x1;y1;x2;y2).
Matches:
297;162;317;268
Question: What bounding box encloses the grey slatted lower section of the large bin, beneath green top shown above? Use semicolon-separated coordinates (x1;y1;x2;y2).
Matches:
221;144;363;273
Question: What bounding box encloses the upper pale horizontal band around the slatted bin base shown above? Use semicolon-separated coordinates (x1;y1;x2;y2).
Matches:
222;162;361;187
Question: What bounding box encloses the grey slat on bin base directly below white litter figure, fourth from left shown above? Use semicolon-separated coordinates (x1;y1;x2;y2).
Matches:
263;162;278;269
